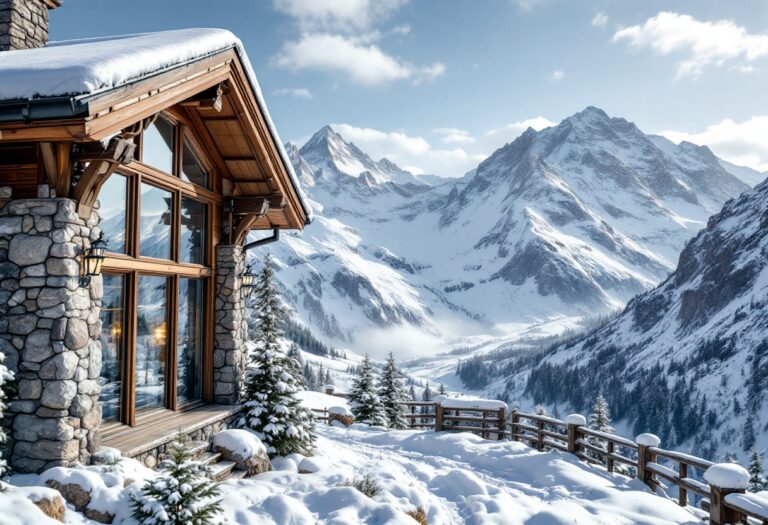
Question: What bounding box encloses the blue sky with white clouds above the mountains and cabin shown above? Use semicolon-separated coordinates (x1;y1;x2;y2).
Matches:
50;0;768;177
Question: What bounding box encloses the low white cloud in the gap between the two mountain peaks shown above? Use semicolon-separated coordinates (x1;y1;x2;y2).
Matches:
331;124;486;177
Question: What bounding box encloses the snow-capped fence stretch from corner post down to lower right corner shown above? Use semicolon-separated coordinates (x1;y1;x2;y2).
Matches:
505;410;768;525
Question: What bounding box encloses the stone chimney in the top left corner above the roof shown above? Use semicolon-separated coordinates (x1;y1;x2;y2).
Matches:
0;0;61;51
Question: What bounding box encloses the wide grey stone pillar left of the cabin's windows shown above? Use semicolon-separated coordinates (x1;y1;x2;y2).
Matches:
0;198;102;472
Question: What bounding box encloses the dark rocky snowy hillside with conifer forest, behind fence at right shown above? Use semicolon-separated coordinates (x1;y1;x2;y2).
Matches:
479;181;768;459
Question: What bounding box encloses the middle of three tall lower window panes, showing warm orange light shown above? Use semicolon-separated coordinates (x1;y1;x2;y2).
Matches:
135;275;168;409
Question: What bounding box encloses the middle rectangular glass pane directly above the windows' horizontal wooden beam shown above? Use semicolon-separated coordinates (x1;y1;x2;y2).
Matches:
139;183;173;259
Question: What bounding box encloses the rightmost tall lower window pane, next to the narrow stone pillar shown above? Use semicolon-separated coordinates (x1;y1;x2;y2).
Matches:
176;278;205;405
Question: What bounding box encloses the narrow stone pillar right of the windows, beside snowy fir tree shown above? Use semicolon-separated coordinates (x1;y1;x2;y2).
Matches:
213;245;248;405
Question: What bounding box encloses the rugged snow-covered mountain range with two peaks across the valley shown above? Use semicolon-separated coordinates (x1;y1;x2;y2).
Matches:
260;108;748;351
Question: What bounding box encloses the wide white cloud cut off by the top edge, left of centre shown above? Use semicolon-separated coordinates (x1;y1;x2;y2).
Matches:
274;0;408;33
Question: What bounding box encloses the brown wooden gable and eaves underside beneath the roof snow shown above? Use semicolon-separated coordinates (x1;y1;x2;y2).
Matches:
0;49;311;229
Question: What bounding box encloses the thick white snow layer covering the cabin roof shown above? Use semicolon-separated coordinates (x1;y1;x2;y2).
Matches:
0;28;312;220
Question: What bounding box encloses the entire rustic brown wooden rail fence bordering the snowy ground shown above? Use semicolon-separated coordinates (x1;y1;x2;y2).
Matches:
315;384;768;525
